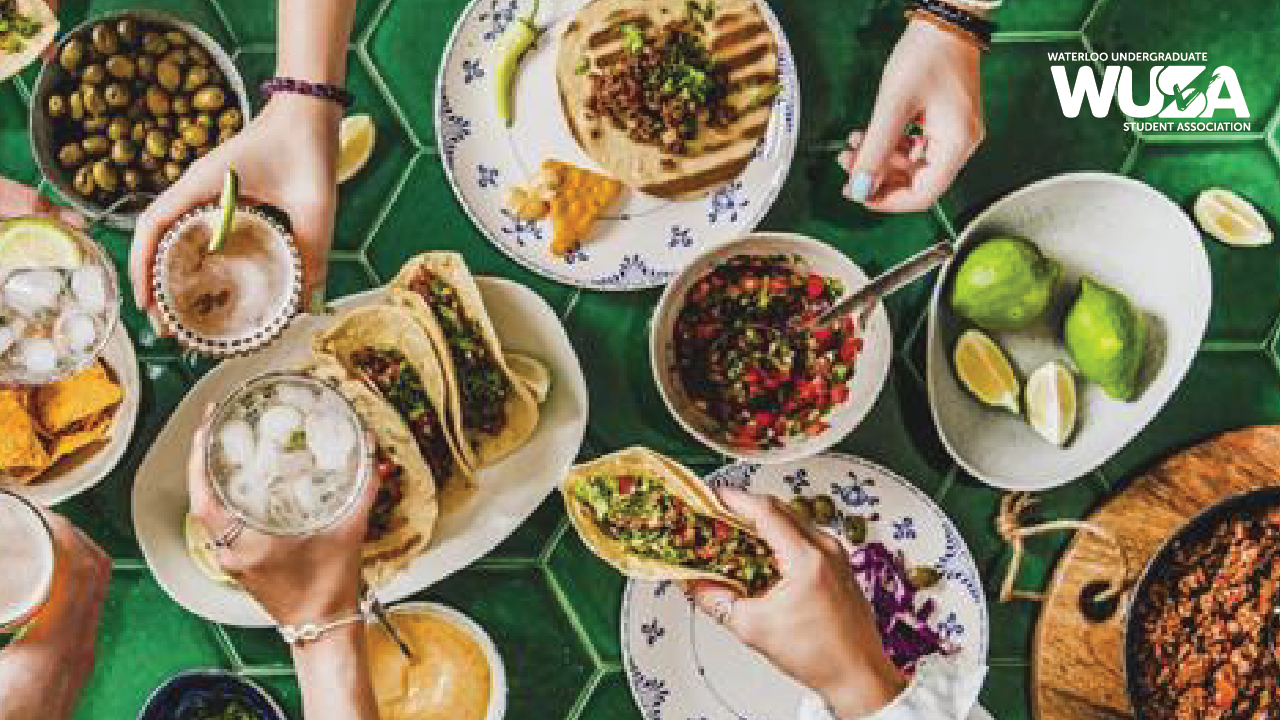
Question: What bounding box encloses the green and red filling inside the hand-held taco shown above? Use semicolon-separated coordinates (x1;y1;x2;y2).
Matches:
573;474;778;594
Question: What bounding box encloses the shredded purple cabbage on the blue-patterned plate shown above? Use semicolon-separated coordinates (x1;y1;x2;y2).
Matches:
850;542;959;675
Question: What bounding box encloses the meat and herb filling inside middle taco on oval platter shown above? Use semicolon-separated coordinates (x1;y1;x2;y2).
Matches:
351;347;454;483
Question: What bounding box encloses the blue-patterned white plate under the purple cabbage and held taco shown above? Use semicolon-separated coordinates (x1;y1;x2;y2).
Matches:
622;454;989;720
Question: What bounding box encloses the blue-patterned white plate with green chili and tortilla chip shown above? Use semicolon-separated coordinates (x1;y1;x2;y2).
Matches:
435;0;800;291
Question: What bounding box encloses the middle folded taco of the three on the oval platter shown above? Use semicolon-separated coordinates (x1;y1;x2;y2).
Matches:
315;299;475;502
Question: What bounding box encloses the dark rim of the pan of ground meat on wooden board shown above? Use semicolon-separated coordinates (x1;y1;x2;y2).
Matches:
1123;487;1280;720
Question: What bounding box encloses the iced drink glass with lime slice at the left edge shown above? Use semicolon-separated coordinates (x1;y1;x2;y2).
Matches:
0;217;120;386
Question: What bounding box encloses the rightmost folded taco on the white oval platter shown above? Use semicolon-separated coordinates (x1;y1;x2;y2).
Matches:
392;252;539;468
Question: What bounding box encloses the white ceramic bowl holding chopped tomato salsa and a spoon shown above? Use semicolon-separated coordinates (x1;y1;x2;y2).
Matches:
649;232;893;464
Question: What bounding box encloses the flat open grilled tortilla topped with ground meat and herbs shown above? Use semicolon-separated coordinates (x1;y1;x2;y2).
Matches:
556;0;780;200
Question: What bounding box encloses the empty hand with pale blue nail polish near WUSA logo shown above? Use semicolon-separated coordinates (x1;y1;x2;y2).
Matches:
837;20;986;213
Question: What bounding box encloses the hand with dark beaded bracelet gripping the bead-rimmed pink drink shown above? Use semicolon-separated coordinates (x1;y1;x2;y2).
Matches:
129;94;342;333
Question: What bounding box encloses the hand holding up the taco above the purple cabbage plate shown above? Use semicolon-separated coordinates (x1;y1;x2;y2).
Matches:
686;491;905;720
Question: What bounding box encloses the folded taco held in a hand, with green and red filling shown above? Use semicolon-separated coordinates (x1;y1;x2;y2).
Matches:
561;447;778;596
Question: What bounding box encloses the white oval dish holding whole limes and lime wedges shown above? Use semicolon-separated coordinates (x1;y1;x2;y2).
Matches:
925;173;1212;491
